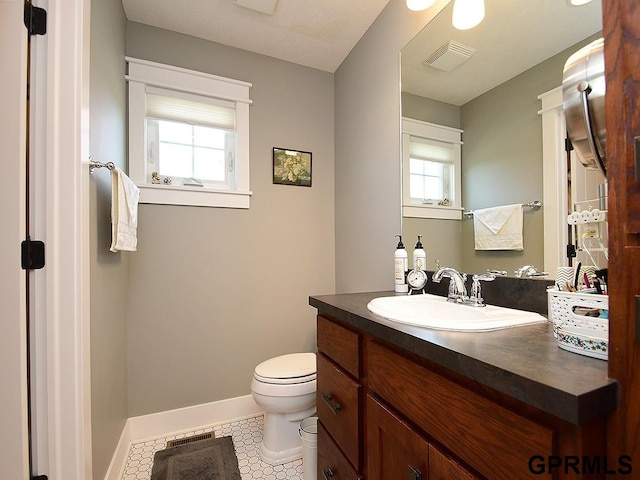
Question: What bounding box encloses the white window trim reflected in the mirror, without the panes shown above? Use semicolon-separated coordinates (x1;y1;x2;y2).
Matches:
402;118;463;220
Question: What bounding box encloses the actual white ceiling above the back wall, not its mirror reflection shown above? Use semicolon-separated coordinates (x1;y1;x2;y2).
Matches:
122;0;389;73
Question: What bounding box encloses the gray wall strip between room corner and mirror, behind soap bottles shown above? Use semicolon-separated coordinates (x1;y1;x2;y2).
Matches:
335;0;444;293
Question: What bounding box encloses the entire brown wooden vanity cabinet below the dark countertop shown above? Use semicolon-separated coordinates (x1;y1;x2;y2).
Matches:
317;314;606;480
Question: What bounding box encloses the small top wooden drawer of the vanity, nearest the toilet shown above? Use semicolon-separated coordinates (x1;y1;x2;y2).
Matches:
318;315;360;378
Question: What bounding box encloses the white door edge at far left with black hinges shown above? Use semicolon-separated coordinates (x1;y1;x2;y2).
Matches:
0;0;29;479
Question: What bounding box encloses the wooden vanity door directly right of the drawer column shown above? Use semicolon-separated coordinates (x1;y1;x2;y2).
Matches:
366;396;428;480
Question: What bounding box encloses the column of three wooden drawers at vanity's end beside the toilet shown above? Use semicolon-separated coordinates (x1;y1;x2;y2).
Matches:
316;316;363;480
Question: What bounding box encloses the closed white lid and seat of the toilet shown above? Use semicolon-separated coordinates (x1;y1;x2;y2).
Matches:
254;353;316;383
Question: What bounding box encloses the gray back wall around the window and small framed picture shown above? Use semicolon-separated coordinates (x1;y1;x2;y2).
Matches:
127;23;335;416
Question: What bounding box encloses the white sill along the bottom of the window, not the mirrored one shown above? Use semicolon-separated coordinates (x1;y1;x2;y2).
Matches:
138;184;252;208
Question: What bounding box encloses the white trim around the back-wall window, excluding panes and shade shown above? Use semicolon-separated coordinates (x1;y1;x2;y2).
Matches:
125;57;252;208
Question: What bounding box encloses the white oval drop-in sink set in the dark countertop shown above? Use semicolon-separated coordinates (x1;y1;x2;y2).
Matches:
367;294;547;332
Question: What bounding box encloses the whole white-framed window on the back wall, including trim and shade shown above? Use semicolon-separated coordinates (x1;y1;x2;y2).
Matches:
127;58;251;208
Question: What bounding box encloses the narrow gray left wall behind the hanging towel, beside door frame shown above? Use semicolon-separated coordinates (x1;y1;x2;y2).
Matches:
90;0;130;479
